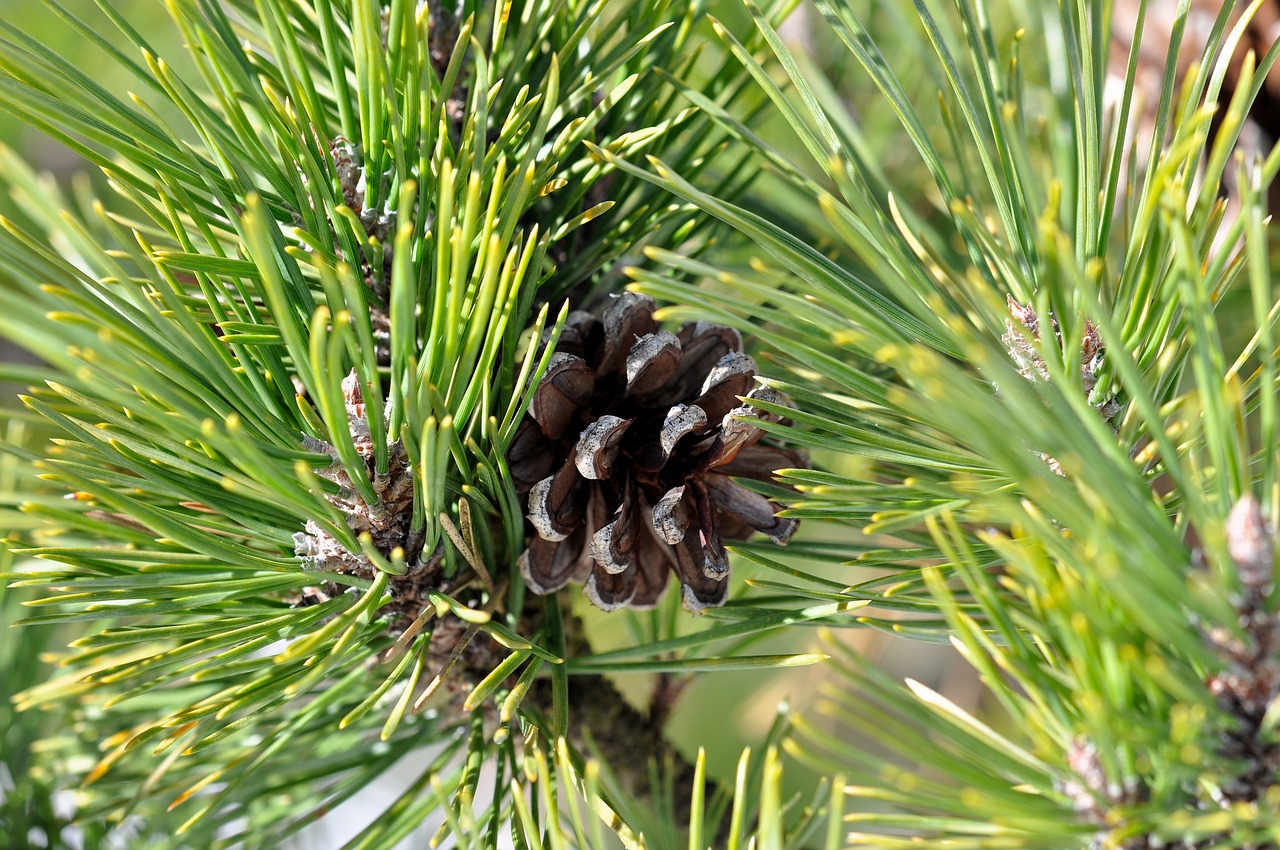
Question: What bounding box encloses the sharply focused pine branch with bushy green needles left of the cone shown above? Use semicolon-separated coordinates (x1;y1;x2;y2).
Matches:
0;0;803;846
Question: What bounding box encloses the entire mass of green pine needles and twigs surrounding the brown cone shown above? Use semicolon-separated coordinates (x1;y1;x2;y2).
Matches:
0;0;1280;850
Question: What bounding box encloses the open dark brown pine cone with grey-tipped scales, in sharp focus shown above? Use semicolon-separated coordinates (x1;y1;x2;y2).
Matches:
507;293;804;611
